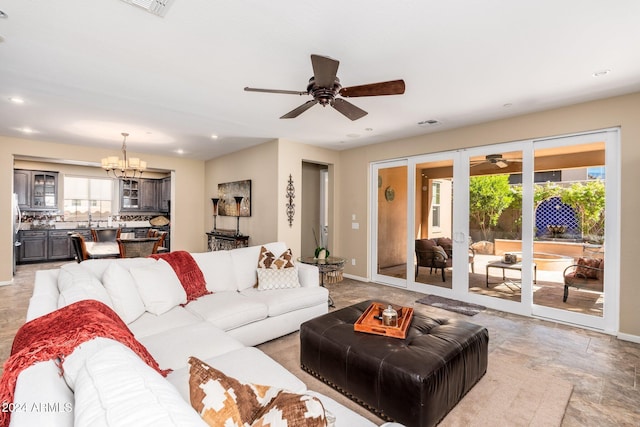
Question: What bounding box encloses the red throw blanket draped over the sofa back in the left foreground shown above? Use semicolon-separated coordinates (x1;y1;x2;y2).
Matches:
0;300;171;427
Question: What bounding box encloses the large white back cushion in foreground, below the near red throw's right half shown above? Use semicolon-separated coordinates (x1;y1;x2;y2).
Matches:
74;345;205;427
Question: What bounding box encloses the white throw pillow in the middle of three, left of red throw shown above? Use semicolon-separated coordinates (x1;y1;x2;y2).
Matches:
102;261;145;324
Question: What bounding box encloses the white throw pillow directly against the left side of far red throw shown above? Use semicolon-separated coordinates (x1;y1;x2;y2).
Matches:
129;260;187;316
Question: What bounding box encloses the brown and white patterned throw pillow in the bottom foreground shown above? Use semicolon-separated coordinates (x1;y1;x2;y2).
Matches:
189;357;327;427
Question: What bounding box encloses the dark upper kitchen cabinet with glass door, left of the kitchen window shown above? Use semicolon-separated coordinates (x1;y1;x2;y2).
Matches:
13;169;58;210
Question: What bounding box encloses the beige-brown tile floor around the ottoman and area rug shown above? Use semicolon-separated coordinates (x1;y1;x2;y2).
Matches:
0;263;640;426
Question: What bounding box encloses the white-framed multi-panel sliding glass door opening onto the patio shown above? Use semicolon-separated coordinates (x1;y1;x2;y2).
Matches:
372;130;619;331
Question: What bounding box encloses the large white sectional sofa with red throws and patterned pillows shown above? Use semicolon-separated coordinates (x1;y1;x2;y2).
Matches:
10;242;374;427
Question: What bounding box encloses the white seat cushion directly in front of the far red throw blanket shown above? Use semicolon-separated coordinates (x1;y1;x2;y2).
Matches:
185;292;268;331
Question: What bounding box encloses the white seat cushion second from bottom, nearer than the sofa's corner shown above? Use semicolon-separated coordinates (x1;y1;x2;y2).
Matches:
140;321;244;369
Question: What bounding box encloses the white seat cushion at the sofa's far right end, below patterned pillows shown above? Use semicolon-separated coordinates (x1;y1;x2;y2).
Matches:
241;286;329;317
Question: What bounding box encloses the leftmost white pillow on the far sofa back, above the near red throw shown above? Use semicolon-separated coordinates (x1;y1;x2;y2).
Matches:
58;263;113;308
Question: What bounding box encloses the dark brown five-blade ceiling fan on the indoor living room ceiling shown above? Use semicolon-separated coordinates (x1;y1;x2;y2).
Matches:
244;55;404;120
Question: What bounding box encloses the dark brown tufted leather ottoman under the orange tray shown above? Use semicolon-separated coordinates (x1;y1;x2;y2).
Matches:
300;301;489;427
